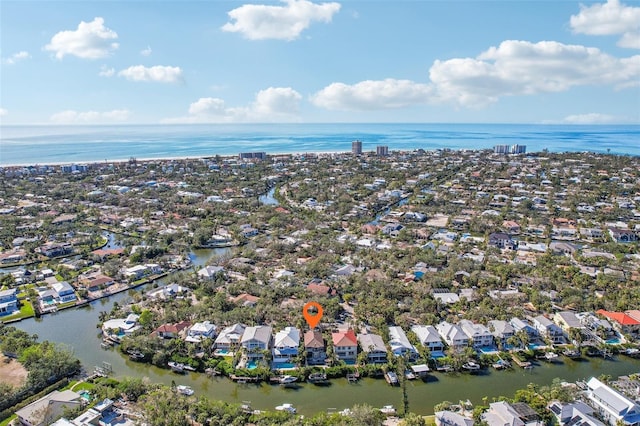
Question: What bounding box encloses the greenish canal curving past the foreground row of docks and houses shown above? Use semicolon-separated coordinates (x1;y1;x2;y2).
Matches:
14;293;640;415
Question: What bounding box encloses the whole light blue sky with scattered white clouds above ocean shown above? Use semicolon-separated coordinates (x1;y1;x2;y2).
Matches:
0;0;640;124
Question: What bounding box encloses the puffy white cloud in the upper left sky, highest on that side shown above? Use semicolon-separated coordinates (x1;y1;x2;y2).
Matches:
44;17;118;59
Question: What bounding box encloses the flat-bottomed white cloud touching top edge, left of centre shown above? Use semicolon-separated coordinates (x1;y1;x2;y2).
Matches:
222;0;340;40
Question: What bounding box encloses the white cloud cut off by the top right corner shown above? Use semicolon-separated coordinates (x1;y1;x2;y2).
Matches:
569;0;640;49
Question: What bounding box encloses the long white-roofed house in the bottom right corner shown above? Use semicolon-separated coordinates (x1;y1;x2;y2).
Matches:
587;377;640;426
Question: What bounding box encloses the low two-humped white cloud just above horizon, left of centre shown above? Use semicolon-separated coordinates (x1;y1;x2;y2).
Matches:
163;87;302;123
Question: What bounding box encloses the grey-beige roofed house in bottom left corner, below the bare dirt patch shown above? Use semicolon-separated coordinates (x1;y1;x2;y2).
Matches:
16;390;82;426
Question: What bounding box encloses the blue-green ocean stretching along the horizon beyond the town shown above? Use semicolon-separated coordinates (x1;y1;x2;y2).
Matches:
0;123;640;166
